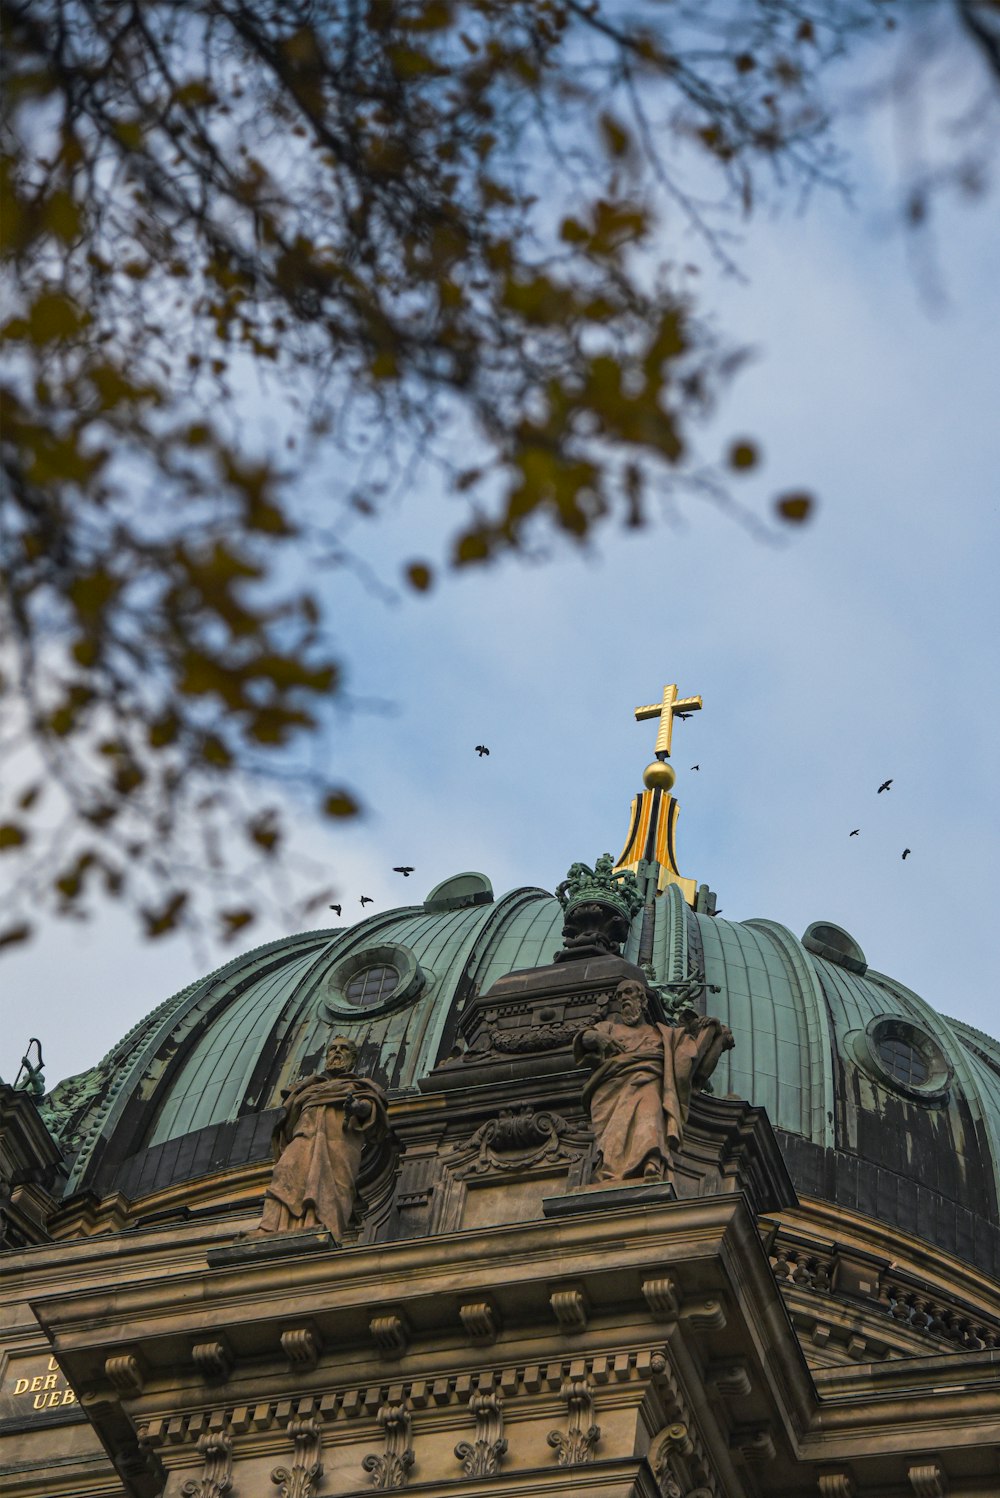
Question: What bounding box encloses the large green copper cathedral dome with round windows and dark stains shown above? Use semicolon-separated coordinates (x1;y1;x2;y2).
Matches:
46;873;1000;1275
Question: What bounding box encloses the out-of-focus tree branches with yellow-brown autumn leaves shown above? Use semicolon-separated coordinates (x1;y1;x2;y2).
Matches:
0;0;975;947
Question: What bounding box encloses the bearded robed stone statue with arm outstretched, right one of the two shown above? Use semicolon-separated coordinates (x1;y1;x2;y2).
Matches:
573;978;734;1182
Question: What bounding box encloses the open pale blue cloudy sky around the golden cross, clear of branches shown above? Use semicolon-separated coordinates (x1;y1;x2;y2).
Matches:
0;23;1000;1083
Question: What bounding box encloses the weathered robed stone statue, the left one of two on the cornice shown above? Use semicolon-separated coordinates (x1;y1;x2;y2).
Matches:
256;1035;388;1243
